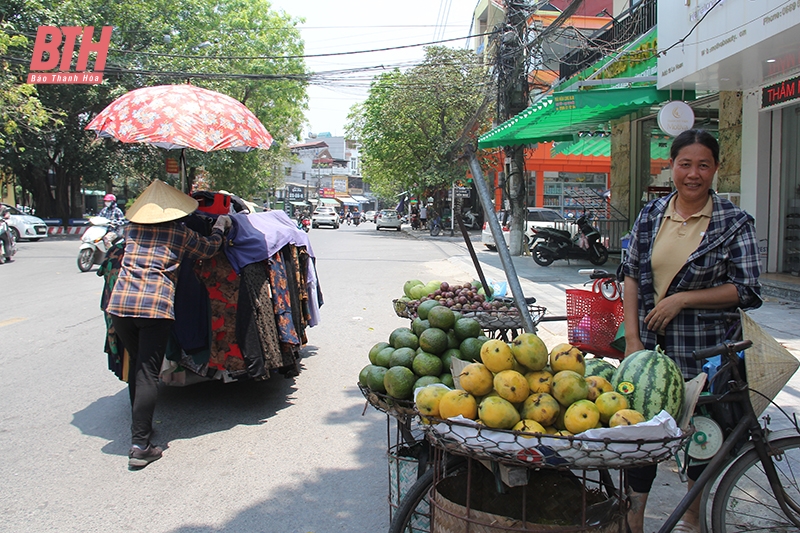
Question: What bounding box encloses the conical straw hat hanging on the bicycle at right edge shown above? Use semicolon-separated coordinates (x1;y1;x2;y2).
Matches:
739;310;800;416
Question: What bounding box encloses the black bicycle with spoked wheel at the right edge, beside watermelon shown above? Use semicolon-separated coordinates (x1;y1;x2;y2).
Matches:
659;313;800;533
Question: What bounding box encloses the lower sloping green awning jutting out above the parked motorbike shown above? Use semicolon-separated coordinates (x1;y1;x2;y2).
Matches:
478;85;694;148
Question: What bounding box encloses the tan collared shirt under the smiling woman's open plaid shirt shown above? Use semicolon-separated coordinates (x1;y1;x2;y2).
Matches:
651;195;714;303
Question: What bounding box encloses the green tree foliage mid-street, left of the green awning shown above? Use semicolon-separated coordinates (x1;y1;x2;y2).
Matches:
347;47;491;202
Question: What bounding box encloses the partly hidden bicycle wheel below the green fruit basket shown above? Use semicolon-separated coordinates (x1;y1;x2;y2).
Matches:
389;456;467;533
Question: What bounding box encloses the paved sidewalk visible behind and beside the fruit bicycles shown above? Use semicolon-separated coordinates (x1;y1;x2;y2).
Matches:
408;231;800;532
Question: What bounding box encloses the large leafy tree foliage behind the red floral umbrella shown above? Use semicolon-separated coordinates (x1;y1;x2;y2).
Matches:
0;0;306;218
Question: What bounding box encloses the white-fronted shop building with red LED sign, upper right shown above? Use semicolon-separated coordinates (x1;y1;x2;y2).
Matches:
658;0;800;299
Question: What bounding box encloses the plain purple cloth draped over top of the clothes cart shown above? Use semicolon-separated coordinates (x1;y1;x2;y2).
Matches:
224;210;315;274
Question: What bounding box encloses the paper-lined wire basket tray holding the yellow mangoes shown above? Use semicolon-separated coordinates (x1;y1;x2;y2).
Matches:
424;413;691;470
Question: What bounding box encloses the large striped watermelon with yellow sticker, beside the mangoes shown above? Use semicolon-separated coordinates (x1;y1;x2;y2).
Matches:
611;346;685;420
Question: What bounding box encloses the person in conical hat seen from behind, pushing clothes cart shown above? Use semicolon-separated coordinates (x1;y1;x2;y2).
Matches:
105;180;231;469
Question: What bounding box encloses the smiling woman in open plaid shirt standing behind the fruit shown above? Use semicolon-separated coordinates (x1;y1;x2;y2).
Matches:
622;130;761;533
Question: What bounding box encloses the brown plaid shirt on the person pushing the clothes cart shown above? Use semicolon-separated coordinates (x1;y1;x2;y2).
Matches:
105;221;222;320
